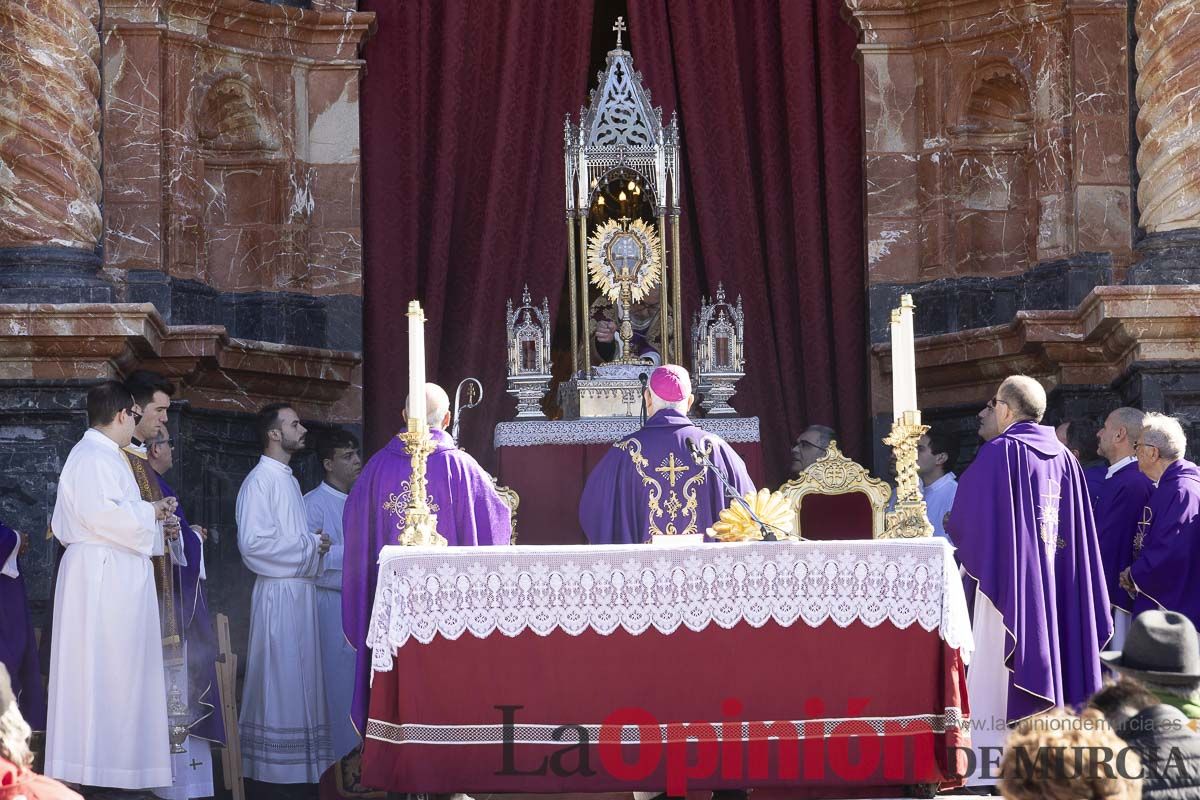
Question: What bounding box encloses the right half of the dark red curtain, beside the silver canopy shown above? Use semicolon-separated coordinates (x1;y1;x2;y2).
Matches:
629;0;868;474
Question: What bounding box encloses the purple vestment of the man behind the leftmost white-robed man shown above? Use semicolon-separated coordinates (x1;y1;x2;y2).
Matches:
151;470;226;745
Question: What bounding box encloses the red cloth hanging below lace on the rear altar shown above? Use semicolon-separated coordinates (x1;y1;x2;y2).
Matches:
496;420;766;545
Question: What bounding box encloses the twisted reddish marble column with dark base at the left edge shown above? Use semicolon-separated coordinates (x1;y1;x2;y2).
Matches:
0;0;112;302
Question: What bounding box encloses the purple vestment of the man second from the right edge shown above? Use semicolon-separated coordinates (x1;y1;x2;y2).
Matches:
1092;461;1154;610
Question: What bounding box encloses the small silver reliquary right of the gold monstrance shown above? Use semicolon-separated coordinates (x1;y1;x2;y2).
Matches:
691;284;745;416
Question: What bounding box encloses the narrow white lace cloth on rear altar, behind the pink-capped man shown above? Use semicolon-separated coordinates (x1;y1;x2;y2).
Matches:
492;416;758;447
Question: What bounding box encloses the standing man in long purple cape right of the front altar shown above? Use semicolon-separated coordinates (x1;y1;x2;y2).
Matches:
946;375;1112;783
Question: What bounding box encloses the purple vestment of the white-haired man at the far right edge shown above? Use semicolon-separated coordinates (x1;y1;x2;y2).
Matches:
1126;458;1200;627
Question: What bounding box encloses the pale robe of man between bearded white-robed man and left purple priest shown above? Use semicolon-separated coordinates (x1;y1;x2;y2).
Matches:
304;481;361;758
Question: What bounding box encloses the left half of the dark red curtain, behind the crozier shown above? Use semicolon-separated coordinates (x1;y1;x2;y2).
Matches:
361;0;593;467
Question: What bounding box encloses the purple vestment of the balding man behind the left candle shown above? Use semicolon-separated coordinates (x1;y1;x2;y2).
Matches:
342;431;512;734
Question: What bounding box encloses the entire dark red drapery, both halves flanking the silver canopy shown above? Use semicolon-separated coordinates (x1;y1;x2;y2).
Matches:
362;0;866;485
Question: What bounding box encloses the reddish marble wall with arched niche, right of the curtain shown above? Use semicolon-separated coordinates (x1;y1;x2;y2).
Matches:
847;0;1134;342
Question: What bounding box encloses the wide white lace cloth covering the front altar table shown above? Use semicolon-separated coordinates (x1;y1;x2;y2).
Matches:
367;539;974;672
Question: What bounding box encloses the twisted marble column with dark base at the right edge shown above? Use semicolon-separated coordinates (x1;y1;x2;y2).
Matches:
1129;0;1200;284
